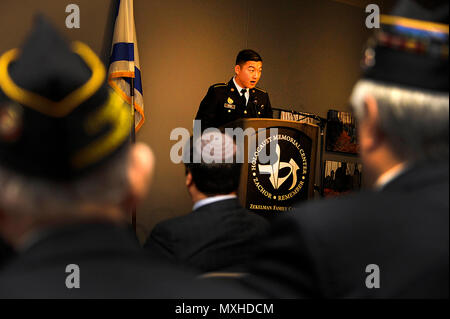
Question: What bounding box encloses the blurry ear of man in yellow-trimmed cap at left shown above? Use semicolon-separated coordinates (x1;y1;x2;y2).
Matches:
127;143;155;202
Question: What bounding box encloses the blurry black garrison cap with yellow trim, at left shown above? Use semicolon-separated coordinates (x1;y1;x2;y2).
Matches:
0;16;132;181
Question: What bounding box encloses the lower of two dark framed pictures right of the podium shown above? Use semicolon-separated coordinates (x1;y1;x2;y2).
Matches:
323;161;363;197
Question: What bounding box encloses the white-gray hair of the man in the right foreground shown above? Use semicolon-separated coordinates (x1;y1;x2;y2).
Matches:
350;80;449;161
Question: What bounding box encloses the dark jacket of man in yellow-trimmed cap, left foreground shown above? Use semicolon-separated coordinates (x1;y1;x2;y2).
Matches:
0;223;258;299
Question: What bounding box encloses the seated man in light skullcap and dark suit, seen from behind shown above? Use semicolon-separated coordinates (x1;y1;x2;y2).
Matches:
145;132;269;272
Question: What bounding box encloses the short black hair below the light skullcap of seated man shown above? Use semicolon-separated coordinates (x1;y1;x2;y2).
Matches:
185;137;242;196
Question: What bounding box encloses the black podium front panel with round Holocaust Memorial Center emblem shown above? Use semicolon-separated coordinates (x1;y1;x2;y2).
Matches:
246;128;311;211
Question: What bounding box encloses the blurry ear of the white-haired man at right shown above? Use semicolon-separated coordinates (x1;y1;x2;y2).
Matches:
360;95;382;152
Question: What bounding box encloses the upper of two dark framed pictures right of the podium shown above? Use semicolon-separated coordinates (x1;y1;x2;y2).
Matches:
325;110;359;155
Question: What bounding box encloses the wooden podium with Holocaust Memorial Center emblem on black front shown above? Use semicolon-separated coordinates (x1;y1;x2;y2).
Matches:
225;118;319;214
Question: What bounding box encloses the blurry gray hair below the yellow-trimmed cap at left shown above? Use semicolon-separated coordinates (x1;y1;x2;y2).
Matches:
0;149;129;216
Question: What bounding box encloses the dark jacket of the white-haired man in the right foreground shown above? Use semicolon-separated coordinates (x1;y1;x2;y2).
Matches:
246;163;449;298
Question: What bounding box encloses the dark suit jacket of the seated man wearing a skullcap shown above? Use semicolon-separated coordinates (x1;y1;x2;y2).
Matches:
145;199;269;272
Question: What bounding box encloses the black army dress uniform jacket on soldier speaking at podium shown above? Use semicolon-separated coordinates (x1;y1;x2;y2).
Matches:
195;79;273;130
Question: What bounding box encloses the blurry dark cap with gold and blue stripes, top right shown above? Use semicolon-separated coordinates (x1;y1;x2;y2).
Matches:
362;0;449;92
